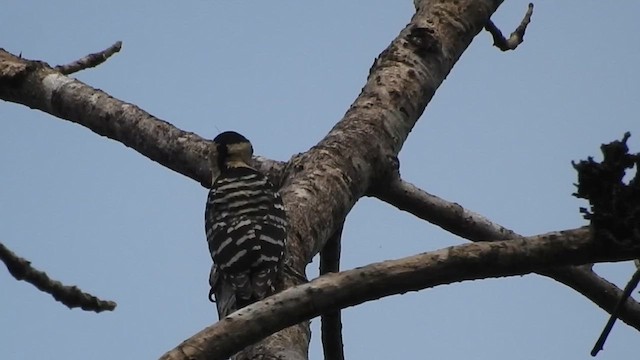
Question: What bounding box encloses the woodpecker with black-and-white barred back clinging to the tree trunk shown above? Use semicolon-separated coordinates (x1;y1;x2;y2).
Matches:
204;131;287;309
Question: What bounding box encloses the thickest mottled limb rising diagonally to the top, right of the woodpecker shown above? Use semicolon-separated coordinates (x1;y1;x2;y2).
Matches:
210;0;516;357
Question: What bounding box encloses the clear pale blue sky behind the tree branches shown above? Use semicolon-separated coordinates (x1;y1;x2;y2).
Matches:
0;0;640;360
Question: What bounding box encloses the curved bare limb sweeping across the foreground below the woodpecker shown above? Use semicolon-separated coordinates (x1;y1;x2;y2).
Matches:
161;228;640;360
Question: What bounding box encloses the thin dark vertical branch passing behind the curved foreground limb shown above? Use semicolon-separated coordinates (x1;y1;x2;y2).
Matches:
320;223;344;360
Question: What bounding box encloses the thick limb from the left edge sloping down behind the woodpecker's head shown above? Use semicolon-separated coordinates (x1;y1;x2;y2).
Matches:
0;49;283;187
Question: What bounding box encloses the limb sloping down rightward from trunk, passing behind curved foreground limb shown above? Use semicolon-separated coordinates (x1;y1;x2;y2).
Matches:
370;179;640;330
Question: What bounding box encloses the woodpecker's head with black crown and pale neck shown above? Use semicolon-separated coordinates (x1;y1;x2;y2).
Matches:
213;131;253;171
